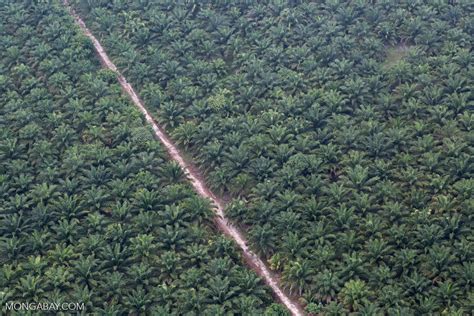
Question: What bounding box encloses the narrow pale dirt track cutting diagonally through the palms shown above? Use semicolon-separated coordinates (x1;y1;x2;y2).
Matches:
63;0;304;315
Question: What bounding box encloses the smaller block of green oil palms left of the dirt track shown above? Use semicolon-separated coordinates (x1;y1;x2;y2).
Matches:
0;1;285;315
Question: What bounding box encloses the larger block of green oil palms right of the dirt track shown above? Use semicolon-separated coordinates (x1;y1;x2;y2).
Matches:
73;0;474;315
